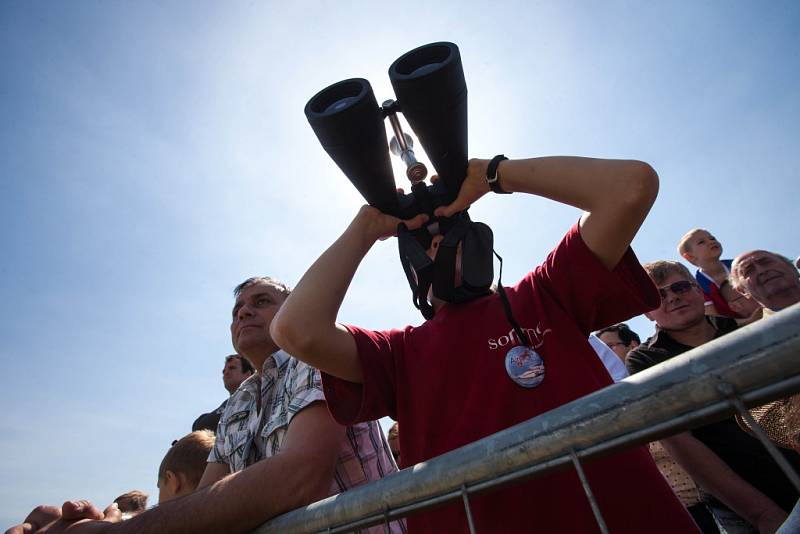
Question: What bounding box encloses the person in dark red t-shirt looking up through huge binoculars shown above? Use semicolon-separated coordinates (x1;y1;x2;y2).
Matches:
272;156;696;533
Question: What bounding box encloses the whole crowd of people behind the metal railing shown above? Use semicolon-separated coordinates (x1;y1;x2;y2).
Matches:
8;157;800;534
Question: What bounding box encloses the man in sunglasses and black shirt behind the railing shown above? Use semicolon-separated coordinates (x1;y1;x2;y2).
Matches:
626;261;800;533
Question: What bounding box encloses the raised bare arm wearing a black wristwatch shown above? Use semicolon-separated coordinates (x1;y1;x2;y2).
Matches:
436;156;658;269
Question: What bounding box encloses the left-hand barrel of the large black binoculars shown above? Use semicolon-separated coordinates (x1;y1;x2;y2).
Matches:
305;78;398;214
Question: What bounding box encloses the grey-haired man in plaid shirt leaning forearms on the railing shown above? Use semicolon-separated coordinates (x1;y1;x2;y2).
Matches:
27;277;405;534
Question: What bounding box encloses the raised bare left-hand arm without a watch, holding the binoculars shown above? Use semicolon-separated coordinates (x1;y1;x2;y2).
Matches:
270;206;427;383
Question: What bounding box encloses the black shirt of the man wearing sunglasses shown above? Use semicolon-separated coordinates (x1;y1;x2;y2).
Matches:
625;317;800;512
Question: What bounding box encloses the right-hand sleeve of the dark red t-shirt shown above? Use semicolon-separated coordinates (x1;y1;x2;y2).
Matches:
520;223;661;337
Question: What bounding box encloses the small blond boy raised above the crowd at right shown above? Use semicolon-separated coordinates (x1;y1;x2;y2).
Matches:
678;228;739;318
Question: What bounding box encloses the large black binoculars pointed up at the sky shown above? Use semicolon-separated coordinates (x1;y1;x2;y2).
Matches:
305;42;467;226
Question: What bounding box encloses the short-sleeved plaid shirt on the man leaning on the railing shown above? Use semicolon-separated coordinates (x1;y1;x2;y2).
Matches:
208;351;405;532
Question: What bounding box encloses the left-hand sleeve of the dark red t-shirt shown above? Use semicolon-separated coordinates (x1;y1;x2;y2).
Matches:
322;325;404;425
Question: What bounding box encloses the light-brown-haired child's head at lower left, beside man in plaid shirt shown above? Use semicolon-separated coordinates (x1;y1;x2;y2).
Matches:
158;430;214;504
